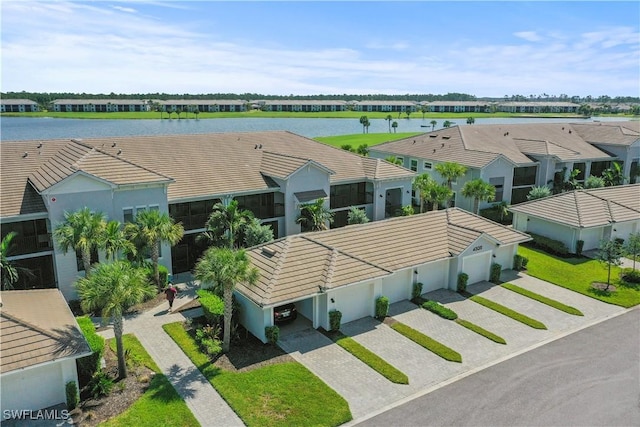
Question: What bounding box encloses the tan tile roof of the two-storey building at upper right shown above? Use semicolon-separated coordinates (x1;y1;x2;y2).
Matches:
373;123;611;168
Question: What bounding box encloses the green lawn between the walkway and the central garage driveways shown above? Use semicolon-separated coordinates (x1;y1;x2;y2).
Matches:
163;322;352;427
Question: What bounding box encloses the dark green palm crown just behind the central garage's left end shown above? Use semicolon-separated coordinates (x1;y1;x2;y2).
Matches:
201;200;254;249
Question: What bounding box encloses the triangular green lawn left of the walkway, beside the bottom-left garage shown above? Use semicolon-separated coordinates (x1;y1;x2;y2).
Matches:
101;334;200;427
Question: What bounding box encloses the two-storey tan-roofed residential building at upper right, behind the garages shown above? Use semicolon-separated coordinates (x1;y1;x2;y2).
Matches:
369;123;624;210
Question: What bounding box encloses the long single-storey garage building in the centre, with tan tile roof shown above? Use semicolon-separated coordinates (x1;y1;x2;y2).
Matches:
236;208;531;341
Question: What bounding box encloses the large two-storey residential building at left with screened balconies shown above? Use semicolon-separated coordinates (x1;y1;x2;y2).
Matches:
0;131;415;299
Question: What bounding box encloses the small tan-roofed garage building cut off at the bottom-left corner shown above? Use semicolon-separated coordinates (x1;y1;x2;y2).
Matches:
0;289;91;421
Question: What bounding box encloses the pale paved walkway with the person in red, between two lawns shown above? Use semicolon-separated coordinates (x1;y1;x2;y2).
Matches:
99;276;244;427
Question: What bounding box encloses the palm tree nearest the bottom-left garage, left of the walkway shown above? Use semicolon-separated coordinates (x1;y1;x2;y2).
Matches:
76;261;155;379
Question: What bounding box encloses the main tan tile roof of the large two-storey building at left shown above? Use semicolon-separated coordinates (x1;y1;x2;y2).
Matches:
0;131;415;216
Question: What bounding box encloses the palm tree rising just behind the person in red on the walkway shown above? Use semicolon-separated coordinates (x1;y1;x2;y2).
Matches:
125;209;184;289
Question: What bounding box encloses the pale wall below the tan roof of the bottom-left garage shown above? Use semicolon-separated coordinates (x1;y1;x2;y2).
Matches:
1;364;66;411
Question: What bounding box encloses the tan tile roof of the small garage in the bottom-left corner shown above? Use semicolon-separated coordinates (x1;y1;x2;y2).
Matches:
0;289;91;373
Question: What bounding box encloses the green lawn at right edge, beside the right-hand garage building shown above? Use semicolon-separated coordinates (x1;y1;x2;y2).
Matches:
518;246;640;308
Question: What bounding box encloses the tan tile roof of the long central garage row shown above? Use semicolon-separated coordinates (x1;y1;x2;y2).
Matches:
238;208;530;305
